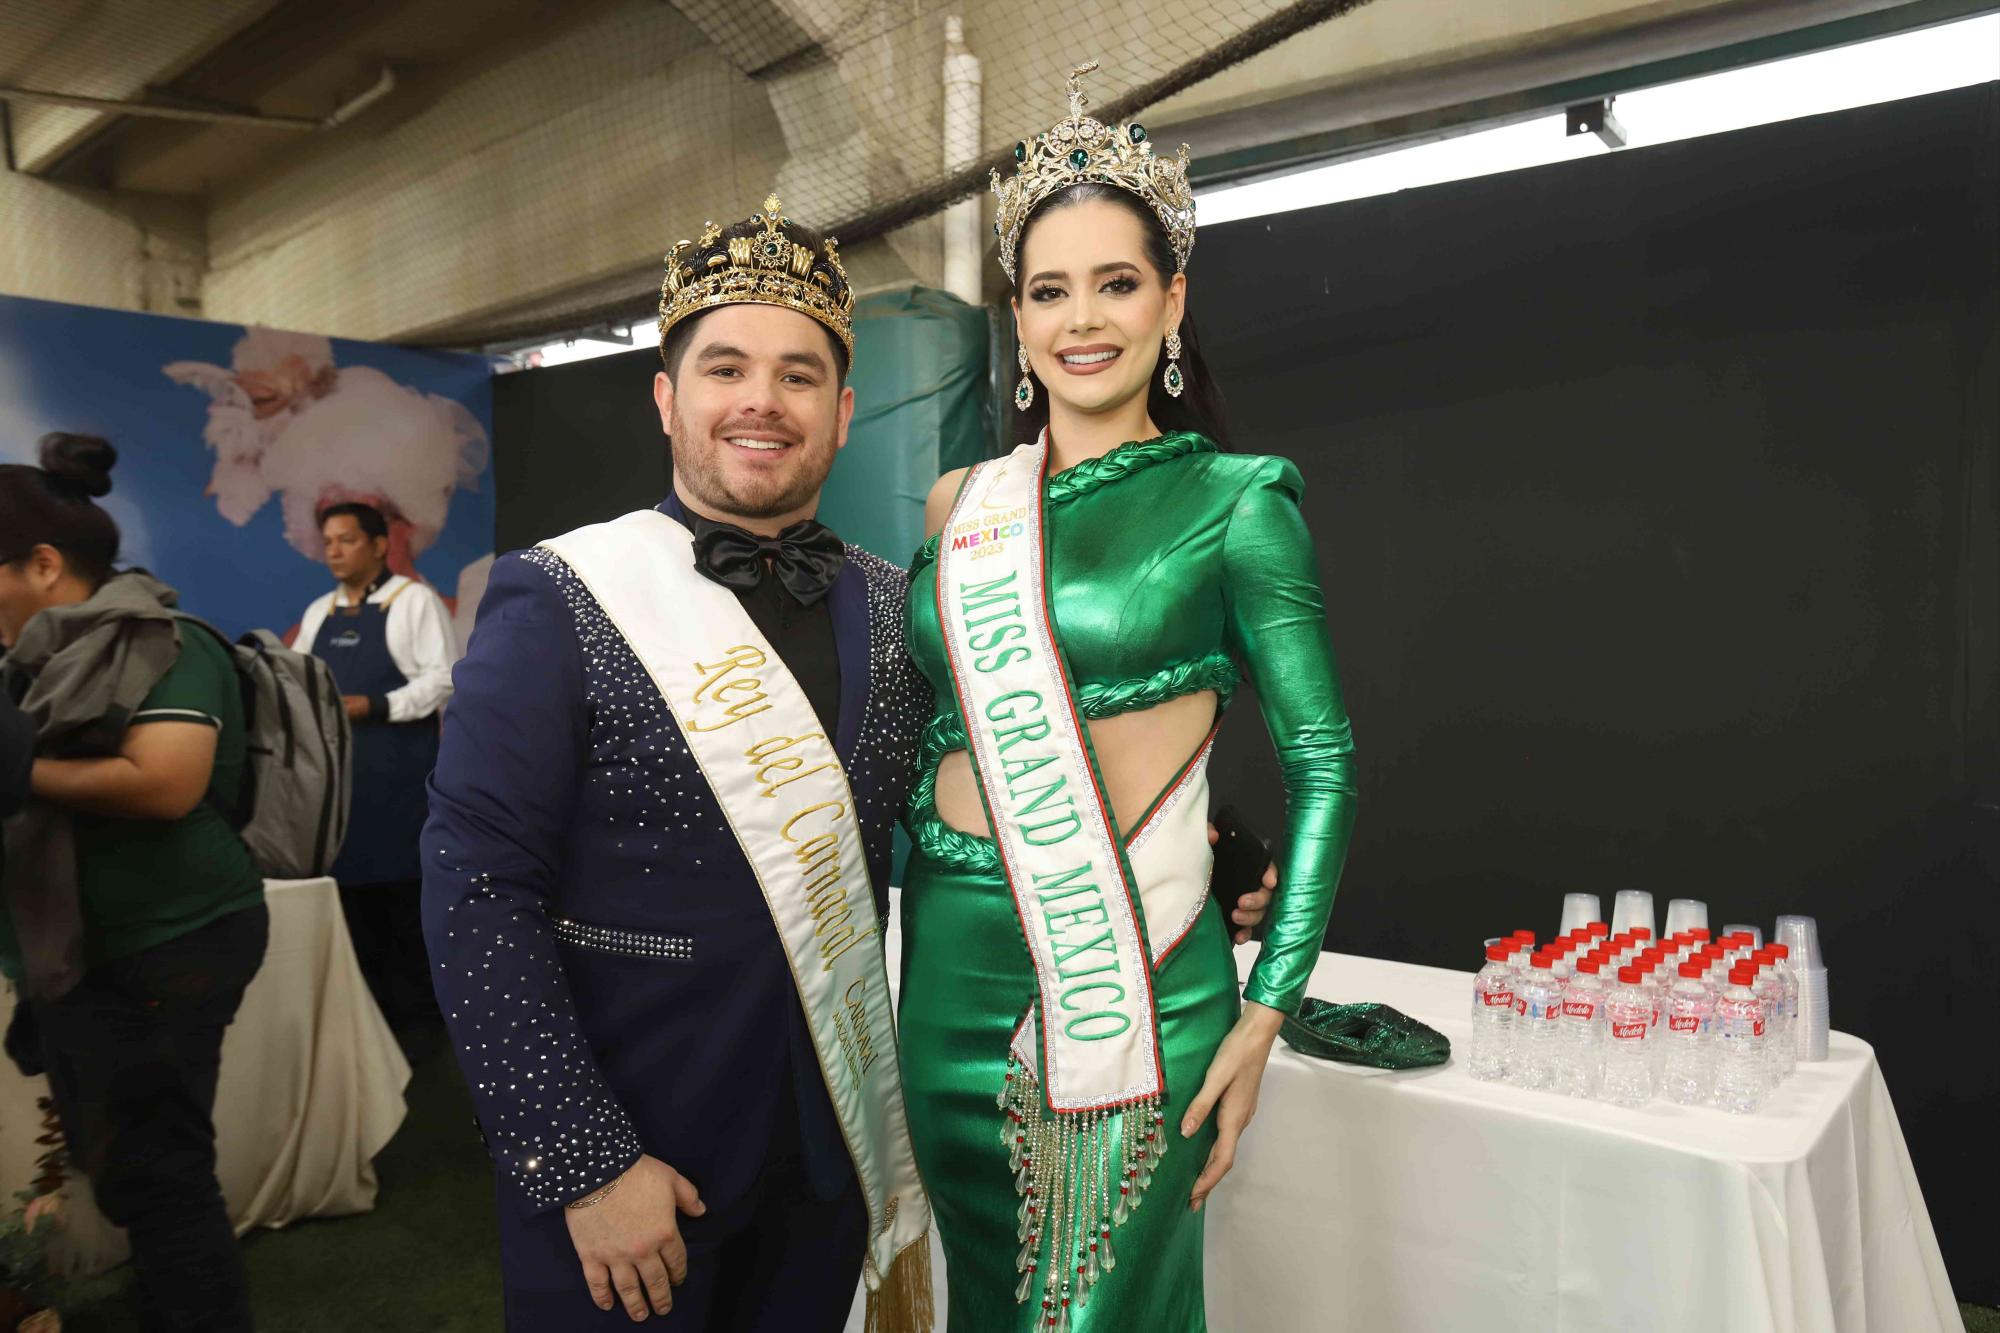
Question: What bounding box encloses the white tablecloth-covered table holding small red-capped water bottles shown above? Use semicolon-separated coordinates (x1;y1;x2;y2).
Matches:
848;896;1964;1333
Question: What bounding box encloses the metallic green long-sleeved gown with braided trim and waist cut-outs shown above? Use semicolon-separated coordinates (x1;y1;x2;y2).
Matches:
900;432;1354;1333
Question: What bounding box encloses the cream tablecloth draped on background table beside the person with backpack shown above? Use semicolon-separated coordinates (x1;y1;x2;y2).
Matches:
0;879;410;1273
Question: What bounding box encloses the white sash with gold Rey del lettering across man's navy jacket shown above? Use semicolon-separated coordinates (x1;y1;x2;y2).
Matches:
542;510;934;1333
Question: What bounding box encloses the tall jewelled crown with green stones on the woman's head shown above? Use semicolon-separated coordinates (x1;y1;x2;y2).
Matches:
992;60;1194;282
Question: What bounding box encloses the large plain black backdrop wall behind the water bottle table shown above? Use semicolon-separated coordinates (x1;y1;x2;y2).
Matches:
1190;84;2000;1301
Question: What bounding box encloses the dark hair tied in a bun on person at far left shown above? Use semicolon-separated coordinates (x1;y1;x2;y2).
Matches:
0;430;118;590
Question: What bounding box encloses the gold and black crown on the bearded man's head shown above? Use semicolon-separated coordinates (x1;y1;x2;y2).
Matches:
660;194;854;360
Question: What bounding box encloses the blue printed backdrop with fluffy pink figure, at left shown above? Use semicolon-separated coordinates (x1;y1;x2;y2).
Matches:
0;296;494;646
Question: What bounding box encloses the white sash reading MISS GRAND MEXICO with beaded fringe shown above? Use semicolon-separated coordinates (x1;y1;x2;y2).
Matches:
938;432;1212;1333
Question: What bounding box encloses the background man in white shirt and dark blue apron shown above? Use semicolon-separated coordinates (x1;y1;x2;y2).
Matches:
294;504;456;1039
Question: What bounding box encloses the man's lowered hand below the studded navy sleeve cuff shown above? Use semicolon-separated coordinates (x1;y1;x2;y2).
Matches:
562;1157;708;1323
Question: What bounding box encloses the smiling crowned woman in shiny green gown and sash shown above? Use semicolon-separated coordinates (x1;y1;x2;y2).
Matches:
900;64;1354;1333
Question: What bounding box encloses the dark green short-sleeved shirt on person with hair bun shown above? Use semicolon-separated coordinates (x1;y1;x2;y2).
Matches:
0;624;264;977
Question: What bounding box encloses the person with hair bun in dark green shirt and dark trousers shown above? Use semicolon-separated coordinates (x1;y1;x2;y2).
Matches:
0;434;270;1333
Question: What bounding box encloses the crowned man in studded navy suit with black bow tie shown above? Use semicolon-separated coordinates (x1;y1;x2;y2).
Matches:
424;198;1272;1333
